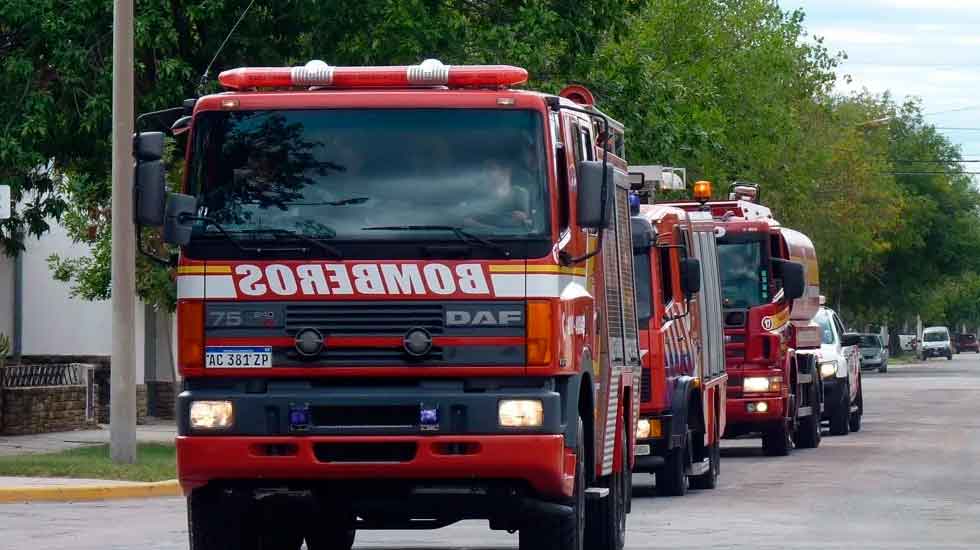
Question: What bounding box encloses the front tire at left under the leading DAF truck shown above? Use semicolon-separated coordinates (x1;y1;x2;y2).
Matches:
187;485;258;550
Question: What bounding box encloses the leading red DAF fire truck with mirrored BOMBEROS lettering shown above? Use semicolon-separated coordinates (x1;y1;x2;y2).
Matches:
135;60;640;550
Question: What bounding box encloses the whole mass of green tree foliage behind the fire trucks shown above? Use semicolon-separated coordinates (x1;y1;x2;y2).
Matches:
7;0;980;325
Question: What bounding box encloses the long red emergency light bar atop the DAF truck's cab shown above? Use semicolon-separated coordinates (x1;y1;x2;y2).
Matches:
218;59;527;90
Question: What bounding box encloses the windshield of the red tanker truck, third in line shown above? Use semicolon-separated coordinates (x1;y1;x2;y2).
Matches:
718;240;769;308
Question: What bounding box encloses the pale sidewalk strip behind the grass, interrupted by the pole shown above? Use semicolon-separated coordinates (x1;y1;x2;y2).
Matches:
0;423;177;456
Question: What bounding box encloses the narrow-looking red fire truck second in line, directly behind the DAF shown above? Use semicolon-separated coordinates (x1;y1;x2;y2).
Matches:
633;204;727;496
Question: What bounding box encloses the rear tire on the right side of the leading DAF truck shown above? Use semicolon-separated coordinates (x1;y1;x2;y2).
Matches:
585;419;632;550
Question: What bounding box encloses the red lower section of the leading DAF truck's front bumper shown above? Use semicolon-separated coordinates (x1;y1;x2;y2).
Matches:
177;435;575;498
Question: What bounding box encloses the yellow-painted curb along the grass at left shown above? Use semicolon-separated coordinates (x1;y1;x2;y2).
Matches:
0;479;184;504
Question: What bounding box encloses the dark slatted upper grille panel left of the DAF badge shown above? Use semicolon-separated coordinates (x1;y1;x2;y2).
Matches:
286;302;445;336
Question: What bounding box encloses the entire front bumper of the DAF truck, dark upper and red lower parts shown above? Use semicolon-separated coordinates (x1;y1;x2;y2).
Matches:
177;378;575;499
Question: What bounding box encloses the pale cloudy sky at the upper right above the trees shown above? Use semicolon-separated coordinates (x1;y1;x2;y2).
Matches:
778;0;980;164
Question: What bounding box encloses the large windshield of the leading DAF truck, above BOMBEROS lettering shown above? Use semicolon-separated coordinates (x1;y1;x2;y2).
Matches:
189;109;550;258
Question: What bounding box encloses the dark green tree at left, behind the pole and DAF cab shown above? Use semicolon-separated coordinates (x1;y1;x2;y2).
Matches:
7;0;644;306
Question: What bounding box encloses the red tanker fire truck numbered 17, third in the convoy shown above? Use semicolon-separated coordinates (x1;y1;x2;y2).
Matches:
677;182;823;456
